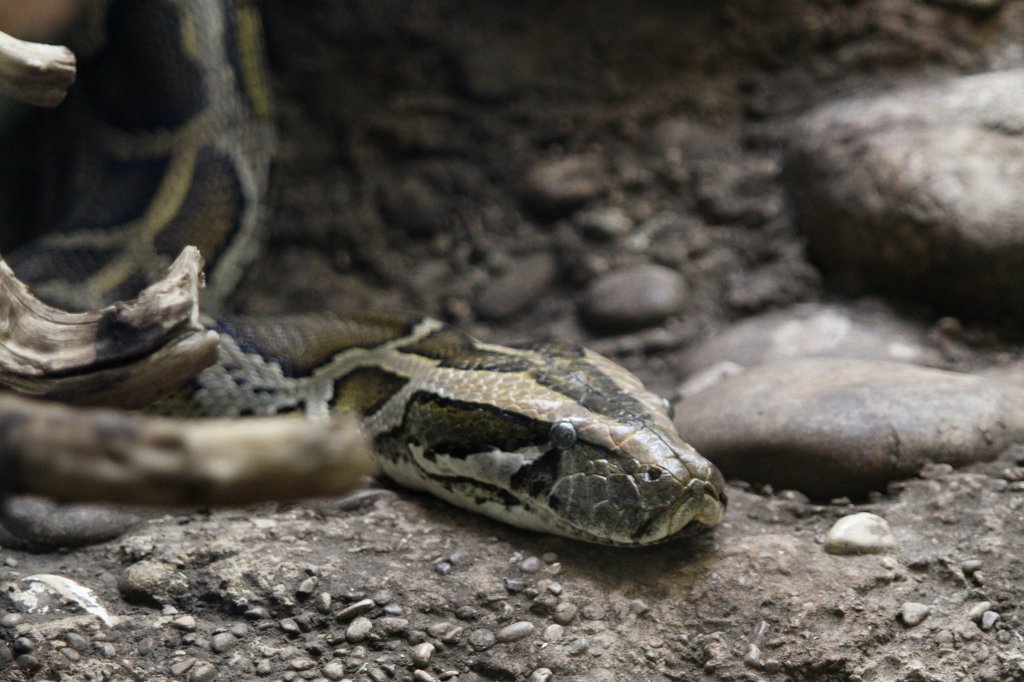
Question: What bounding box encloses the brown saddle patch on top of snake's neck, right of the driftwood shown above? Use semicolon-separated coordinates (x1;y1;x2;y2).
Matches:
214;312;421;378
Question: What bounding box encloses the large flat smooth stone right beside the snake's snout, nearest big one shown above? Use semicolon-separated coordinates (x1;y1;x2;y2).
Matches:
675;357;1024;500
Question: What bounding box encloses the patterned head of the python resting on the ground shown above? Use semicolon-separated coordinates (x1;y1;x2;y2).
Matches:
378;331;726;546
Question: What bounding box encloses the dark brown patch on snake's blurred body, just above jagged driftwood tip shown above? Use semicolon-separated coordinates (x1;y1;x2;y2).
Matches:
154;147;246;266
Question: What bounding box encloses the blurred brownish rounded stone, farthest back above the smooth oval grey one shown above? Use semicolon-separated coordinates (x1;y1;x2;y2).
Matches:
523;155;608;217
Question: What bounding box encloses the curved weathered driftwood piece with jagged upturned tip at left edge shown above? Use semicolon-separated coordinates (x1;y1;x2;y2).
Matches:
0;247;217;408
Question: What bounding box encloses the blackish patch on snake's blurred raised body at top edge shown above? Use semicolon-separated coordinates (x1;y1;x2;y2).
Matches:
88;0;207;131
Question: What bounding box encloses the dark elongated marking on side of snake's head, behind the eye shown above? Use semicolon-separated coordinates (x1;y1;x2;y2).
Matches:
378;391;551;459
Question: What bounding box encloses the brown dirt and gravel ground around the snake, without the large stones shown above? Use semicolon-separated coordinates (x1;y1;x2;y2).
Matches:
0;0;1024;682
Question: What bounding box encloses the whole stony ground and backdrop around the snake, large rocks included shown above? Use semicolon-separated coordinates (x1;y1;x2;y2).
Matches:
0;0;1024;682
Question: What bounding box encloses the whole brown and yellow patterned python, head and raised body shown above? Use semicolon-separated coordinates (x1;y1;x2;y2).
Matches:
10;0;725;545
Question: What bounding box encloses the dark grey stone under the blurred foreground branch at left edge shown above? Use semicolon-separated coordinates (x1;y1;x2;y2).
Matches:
0;496;142;552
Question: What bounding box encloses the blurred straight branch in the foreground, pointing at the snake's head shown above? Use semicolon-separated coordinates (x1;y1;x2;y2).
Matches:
0;394;372;505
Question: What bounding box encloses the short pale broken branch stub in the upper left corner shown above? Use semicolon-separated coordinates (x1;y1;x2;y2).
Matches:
0;27;75;106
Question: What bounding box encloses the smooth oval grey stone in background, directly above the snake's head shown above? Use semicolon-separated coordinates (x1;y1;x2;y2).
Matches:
582;264;686;333
